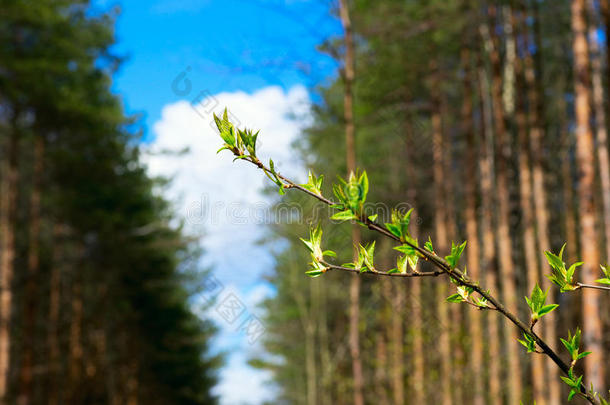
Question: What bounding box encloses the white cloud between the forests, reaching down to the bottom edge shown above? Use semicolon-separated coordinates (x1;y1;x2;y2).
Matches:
144;86;309;405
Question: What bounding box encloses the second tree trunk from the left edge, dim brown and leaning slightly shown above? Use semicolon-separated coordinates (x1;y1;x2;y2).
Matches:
18;136;44;405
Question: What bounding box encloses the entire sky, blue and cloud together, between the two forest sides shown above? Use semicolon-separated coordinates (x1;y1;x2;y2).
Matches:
102;0;341;405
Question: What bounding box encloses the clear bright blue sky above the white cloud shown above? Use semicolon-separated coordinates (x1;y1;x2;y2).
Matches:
105;0;341;134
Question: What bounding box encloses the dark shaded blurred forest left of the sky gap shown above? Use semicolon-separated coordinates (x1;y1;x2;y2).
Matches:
0;0;220;405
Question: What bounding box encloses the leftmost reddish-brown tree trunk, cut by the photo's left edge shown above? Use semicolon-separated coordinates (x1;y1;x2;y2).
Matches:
0;111;20;403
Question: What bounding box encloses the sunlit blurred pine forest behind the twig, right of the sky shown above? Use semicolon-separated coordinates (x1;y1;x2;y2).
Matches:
251;0;610;405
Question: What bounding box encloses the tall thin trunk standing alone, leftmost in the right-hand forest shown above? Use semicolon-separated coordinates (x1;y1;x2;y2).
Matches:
339;0;364;405
